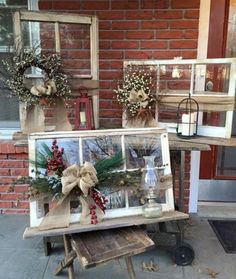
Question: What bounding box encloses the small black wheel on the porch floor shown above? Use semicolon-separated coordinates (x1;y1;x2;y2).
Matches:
172;242;194;266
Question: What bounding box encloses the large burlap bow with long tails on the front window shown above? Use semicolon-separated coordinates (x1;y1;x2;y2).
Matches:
39;162;98;230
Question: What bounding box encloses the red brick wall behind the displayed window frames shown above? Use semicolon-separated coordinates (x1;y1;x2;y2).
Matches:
0;0;200;213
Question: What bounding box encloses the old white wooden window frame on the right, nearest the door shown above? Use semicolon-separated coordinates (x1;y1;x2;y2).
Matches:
123;58;236;138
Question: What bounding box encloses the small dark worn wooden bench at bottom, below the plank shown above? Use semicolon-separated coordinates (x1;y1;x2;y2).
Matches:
55;226;155;279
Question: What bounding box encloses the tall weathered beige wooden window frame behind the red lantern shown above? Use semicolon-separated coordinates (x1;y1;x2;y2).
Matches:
13;11;99;128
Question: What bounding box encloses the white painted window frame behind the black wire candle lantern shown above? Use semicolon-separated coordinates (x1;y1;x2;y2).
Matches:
123;58;236;138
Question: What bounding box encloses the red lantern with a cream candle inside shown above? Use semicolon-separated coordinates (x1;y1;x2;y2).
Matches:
74;87;94;130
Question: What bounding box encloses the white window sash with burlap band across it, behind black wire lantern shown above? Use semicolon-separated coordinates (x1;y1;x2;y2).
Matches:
123;58;236;138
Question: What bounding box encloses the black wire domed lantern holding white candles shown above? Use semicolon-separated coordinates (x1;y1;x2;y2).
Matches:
176;94;199;139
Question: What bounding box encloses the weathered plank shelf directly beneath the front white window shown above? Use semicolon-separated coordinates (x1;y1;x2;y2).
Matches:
23;211;189;238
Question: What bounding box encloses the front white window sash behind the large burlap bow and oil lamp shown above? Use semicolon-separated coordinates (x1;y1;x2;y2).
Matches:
29;128;174;227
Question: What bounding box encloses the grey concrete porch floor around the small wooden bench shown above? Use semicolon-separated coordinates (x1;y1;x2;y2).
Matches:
0;215;236;279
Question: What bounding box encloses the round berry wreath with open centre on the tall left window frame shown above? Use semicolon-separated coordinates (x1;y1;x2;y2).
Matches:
2;50;71;106
